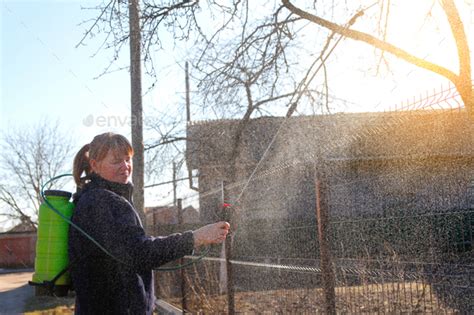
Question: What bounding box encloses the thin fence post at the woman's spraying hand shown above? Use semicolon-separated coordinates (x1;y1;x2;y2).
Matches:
221;181;235;315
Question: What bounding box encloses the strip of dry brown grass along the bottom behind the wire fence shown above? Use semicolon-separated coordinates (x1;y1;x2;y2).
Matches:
168;282;456;314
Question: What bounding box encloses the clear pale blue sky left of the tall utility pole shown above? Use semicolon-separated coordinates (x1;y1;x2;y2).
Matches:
1;1;130;140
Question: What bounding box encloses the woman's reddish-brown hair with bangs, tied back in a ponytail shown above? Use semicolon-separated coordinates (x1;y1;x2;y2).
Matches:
73;132;133;187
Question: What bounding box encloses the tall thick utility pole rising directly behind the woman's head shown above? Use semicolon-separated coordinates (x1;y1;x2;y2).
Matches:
128;0;146;225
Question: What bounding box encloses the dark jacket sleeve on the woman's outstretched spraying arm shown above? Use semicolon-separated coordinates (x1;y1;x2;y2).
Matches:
75;190;194;269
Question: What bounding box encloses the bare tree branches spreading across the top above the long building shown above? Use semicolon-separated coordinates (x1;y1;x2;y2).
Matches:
81;0;473;188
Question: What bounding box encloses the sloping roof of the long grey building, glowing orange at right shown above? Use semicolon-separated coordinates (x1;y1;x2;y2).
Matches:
186;110;474;169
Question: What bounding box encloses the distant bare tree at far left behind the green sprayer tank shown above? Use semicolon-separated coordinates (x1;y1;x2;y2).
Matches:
0;120;72;228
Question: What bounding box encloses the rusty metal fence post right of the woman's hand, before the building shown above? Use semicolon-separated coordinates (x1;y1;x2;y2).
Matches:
316;171;336;314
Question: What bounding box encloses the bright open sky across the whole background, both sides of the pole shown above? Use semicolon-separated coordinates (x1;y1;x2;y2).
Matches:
0;0;474;232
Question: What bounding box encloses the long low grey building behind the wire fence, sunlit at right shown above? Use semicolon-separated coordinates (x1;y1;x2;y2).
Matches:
186;110;474;257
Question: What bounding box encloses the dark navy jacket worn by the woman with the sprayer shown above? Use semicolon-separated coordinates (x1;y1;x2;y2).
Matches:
69;175;194;314
